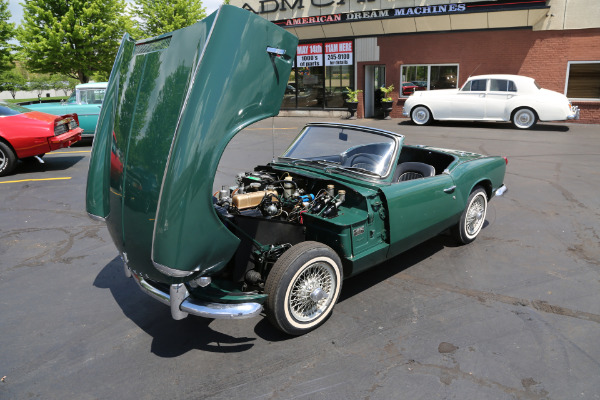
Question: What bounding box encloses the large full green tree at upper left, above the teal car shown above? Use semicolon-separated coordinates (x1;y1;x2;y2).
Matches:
16;0;131;83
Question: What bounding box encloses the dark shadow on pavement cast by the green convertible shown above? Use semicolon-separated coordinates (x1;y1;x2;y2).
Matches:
94;231;466;350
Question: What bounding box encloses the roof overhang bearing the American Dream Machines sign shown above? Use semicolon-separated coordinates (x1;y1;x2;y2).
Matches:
233;0;550;40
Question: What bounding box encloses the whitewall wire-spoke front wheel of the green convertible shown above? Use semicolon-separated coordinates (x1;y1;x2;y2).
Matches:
265;242;343;335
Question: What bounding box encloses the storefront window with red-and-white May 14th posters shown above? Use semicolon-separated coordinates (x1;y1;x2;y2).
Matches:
281;41;354;109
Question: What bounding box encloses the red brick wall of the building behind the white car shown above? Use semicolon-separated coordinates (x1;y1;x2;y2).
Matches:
357;29;600;123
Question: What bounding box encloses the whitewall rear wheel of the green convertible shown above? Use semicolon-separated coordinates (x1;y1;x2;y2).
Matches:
452;187;487;244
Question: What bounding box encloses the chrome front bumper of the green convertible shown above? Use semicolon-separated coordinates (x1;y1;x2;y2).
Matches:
125;265;263;320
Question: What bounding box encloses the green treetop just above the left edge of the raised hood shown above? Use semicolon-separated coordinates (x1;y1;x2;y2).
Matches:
132;0;206;37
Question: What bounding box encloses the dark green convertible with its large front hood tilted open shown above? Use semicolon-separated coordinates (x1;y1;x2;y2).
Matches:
86;5;506;335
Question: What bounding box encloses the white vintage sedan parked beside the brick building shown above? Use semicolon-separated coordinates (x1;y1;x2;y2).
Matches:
403;75;579;129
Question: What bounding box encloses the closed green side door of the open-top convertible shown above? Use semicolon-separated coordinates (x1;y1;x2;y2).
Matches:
382;174;463;257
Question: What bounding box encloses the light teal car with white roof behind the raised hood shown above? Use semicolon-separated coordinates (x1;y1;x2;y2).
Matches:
21;82;108;137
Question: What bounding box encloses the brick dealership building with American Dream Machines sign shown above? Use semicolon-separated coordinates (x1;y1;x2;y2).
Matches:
230;0;600;123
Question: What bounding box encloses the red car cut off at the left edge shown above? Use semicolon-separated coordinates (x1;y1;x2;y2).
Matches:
0;102;83;176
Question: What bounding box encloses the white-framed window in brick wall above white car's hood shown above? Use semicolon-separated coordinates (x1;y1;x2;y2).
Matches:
401;64;458;96
